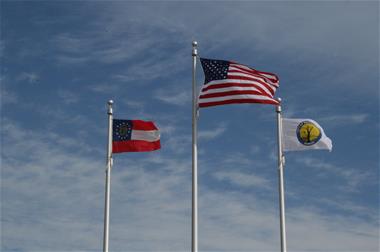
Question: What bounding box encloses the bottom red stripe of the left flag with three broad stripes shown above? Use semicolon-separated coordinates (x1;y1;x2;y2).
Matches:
112;140;161;153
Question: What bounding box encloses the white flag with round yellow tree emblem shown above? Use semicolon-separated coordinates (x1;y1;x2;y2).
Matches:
282;118;332;151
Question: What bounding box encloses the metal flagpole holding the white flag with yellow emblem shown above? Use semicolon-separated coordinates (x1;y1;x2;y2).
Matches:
276;98;286;252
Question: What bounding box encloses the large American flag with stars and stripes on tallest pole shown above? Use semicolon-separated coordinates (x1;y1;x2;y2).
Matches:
198;58;279;108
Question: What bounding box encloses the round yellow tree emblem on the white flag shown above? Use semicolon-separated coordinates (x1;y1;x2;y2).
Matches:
297;121;322;146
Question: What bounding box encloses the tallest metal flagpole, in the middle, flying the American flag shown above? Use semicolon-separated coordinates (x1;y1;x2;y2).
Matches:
191;41;198;252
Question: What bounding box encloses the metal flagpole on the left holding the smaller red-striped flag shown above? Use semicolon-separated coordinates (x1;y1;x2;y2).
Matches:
103;100;113;252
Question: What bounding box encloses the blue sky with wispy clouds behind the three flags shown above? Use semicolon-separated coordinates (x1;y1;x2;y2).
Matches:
0;1;380;251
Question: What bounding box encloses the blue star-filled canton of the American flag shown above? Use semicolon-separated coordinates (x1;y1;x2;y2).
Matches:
201;58;230;84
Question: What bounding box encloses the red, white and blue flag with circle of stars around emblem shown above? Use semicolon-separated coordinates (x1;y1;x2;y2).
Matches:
112;119;161;153
